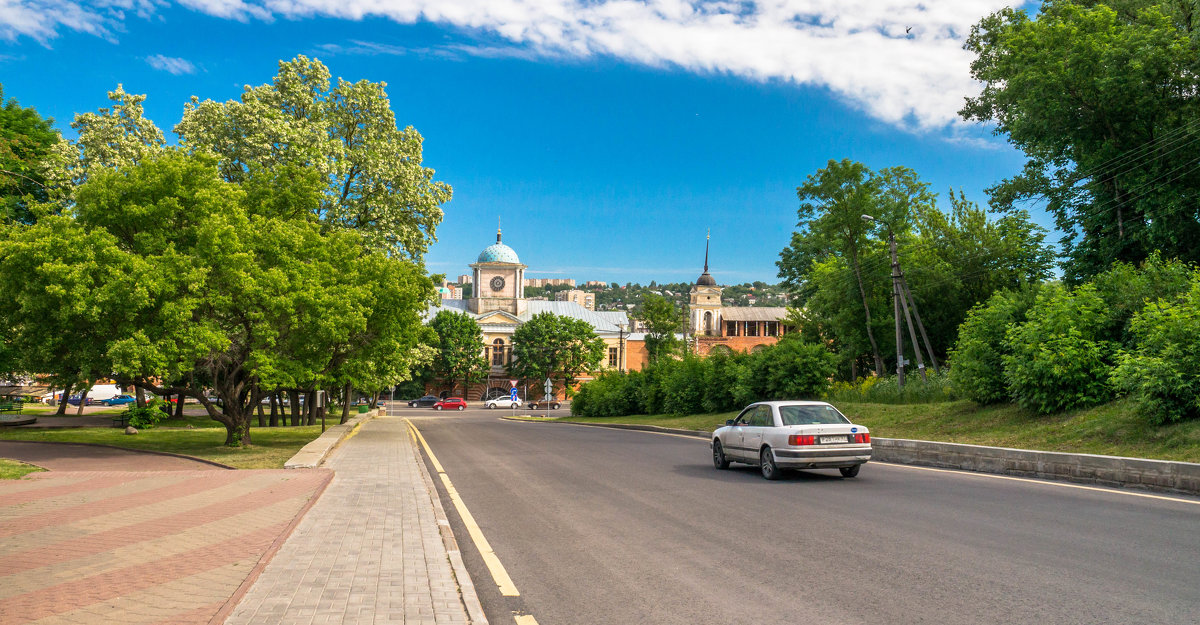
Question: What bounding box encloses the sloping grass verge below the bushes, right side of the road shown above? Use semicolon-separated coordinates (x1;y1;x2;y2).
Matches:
558;401;1200;462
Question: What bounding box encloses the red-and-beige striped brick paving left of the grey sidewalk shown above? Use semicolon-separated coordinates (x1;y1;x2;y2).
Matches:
0;470;332;625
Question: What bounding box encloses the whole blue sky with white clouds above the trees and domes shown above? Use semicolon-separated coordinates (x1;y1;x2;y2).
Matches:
0;0;1041;283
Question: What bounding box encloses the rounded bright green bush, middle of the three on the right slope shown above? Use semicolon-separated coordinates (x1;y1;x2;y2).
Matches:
1002;284;1112;414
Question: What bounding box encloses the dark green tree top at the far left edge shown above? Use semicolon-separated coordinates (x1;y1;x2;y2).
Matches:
0;85;61;224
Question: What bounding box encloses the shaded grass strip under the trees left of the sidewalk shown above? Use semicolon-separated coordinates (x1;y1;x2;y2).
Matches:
0;416;338;469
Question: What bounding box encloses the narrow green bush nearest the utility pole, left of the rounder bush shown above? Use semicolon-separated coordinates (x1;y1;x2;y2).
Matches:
948;288;1037;404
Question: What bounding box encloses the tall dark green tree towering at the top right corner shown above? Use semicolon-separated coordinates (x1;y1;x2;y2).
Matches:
960;0;1200;282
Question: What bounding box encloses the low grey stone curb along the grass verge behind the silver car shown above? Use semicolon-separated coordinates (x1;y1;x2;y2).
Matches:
502;416;1200;495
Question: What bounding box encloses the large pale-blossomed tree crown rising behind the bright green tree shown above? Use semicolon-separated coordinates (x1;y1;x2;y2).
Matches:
175;55;451;256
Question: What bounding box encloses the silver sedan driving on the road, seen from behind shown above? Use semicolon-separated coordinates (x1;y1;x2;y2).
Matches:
712;402;871;480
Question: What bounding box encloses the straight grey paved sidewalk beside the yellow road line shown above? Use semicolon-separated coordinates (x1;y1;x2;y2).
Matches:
226;416;478;625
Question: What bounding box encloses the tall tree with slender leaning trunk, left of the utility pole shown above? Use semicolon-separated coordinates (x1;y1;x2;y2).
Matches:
776;160;934;375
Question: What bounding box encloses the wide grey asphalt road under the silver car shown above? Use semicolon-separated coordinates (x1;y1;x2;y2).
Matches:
394;409;1200;625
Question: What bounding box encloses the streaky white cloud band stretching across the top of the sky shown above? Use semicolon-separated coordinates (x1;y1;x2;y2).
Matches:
0;0;1020;130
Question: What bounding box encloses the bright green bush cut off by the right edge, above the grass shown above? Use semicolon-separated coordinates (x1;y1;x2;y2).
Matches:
1112;274;1200;423
